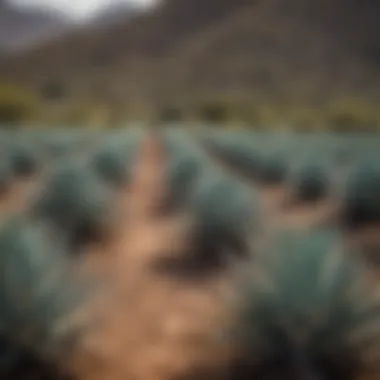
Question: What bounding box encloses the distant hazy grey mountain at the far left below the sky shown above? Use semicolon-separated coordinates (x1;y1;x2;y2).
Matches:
0;0;68;53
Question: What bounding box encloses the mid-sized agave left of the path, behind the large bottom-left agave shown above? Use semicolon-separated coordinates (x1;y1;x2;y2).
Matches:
32;161;113;247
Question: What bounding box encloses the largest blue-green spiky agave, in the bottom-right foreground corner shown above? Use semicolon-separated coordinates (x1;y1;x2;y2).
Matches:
229;231;380;380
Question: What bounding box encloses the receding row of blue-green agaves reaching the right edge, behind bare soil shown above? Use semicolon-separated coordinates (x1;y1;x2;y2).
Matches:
201;132;380;228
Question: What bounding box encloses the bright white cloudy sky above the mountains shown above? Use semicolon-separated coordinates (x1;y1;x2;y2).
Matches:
11;0;155;19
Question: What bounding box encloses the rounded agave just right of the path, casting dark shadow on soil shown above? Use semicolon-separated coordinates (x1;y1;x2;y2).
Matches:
192;171;261;270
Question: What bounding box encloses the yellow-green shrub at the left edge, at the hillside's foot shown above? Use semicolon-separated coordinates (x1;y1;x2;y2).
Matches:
0;85;39;125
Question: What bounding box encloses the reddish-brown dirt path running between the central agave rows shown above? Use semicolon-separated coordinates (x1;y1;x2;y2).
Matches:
69;136;236;380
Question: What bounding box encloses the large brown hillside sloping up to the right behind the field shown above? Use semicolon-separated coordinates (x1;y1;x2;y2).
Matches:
1;0;380;120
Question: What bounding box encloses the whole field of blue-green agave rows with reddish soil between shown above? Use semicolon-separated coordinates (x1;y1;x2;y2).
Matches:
0;127;380;380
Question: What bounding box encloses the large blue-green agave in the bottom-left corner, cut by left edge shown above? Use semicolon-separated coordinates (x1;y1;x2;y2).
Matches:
0;218;90;380
